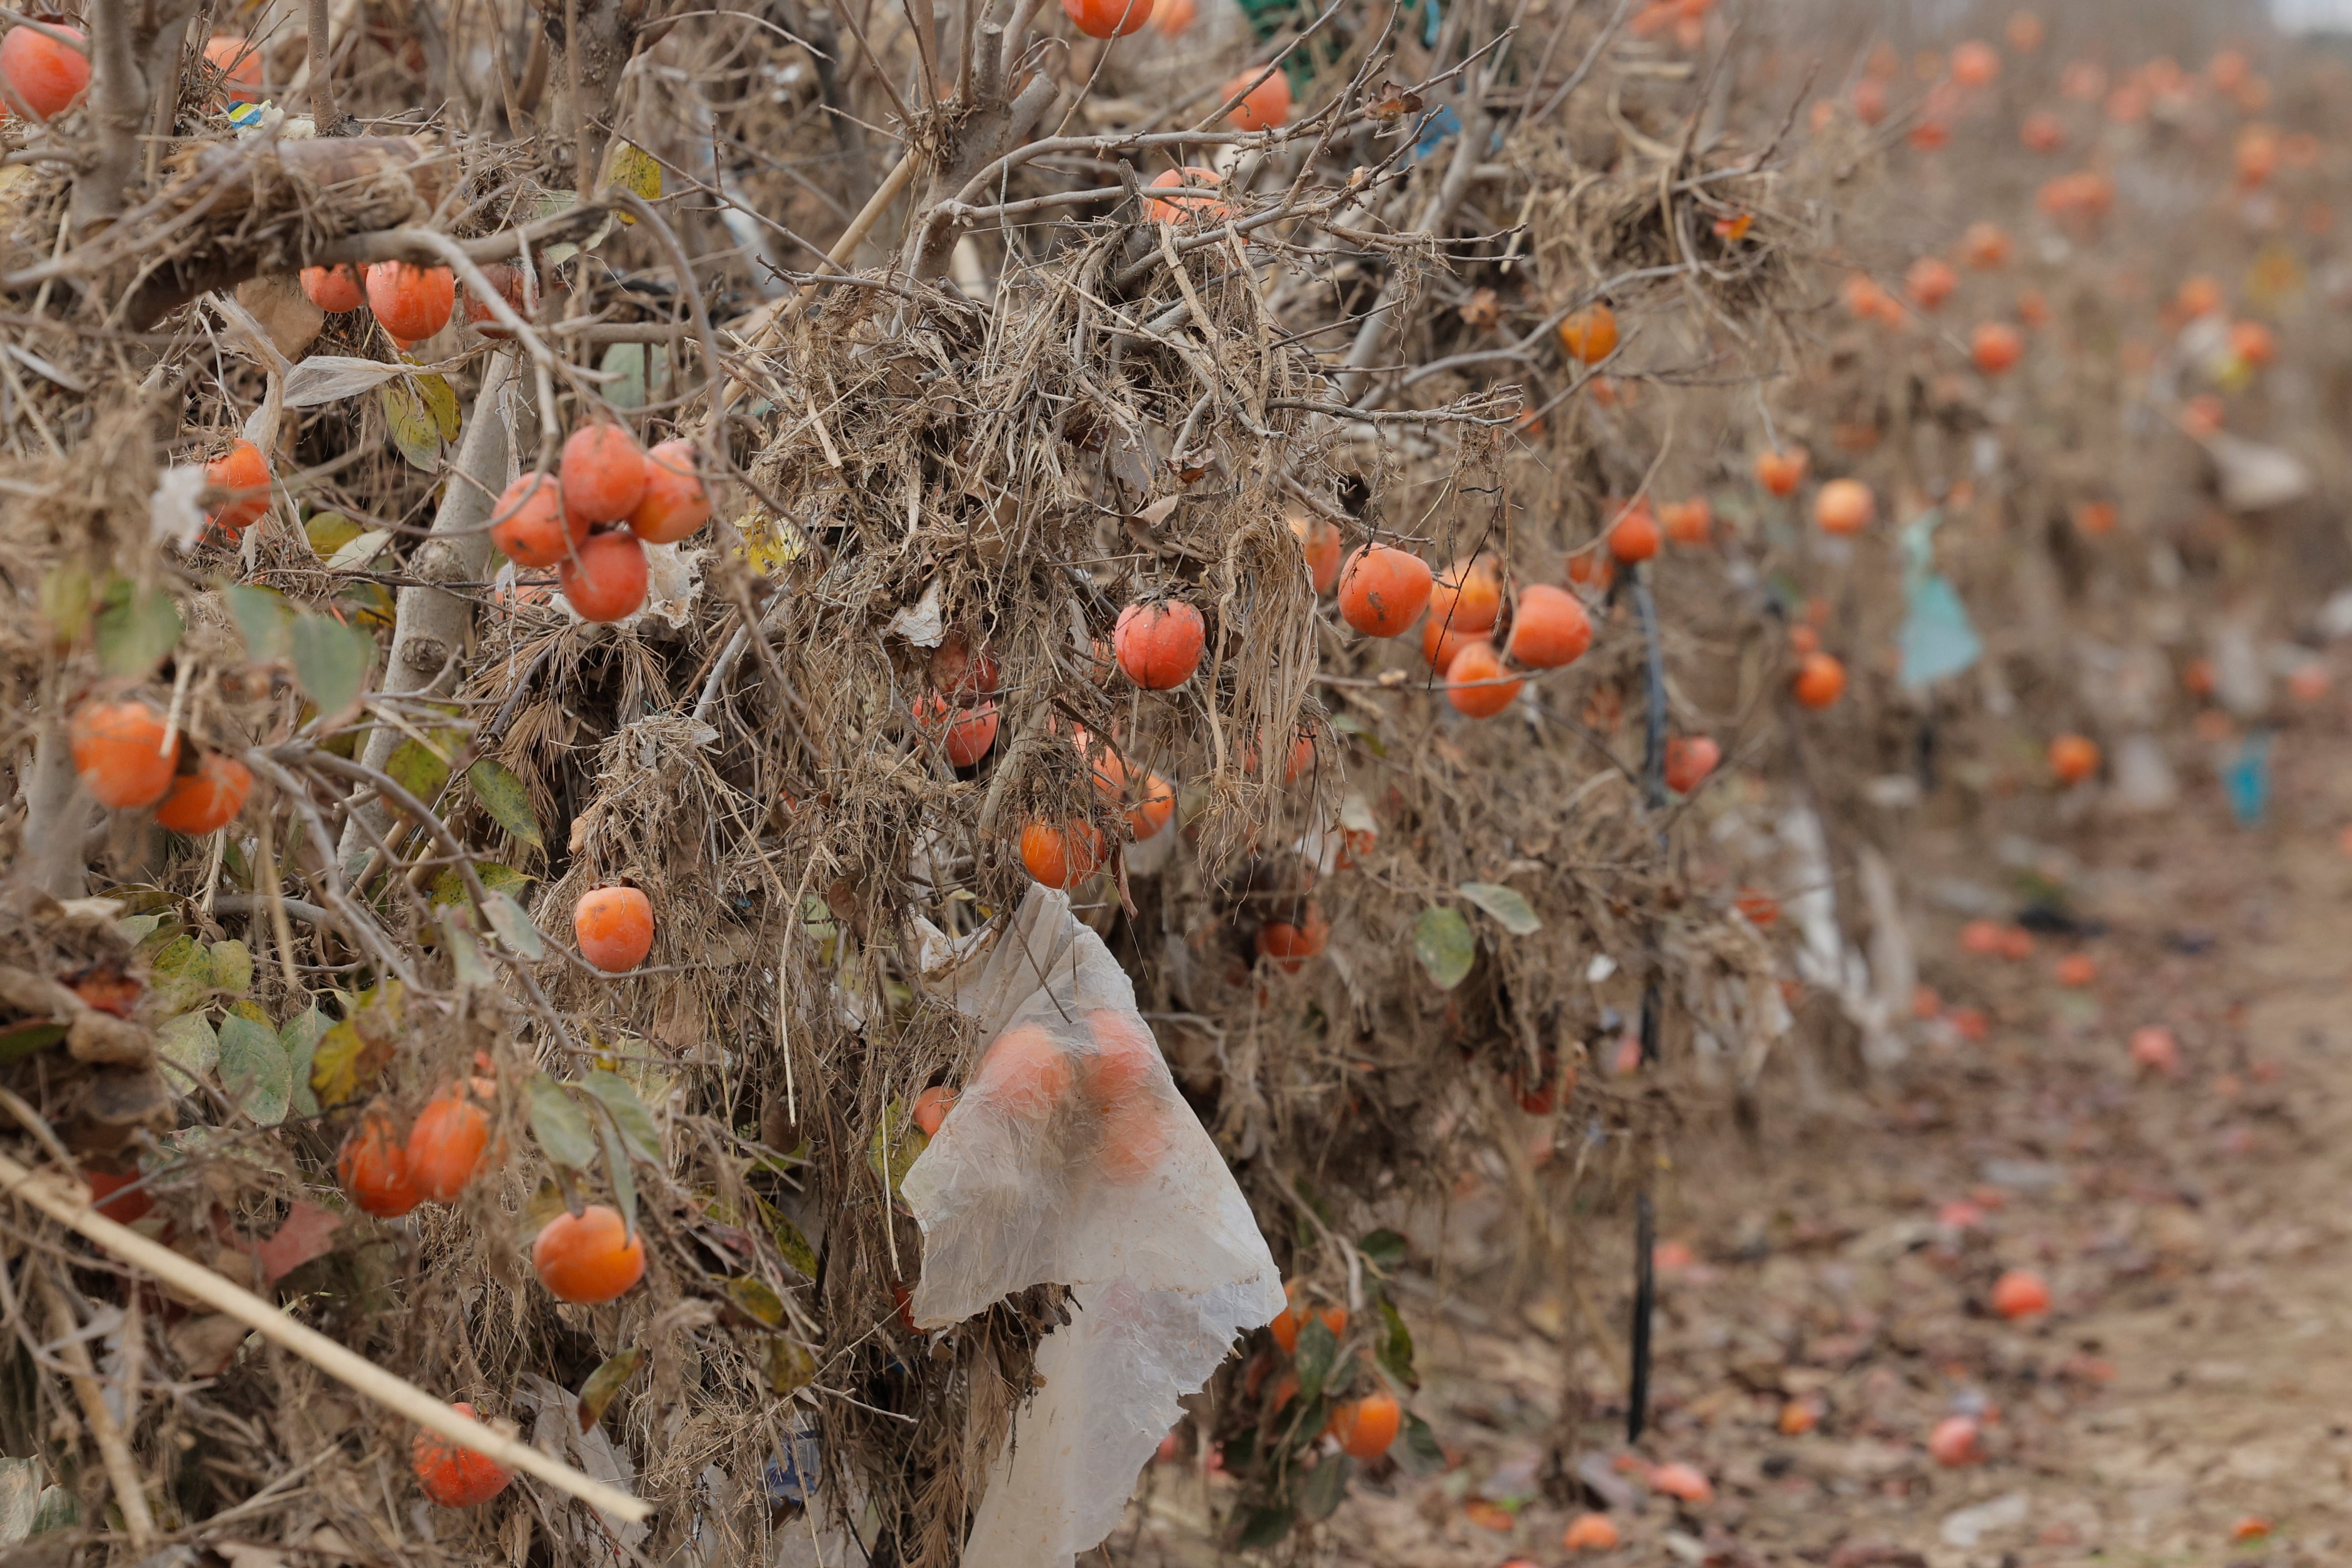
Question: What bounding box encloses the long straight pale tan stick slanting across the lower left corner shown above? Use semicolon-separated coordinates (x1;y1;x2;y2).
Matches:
0;1154;654;1524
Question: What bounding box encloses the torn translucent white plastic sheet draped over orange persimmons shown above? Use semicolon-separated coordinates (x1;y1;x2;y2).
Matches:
901;889;1282;1568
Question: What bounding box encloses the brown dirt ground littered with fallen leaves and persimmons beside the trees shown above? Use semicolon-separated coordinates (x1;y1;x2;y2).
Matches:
1132;731;2352;1568
